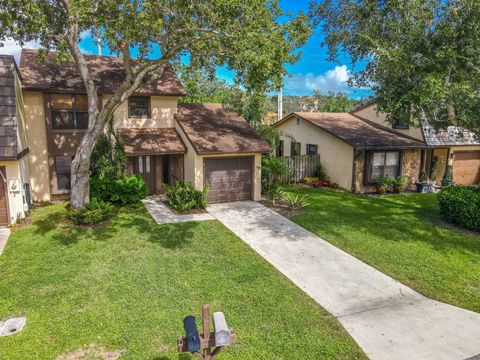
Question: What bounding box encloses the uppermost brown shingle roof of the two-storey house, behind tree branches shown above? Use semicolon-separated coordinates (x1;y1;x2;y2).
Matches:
20;49;185;96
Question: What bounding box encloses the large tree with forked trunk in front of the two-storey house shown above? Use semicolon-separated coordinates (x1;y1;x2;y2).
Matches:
0;0;310;208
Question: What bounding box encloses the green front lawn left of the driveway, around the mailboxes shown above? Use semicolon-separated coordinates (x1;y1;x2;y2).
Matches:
0;205;365;360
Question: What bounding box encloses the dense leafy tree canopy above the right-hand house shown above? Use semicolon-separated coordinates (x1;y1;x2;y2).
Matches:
314;0;480;134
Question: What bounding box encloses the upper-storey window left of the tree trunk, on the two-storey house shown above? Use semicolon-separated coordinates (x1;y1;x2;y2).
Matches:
50;94;88;130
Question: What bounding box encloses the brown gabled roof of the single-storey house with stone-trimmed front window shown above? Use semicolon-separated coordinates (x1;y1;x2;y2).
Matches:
274;112;426;149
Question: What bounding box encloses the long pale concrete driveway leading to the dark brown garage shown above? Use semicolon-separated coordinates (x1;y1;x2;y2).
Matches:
208;201;480;360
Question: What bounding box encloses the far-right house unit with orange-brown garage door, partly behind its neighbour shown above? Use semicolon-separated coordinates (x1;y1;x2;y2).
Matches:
352;104;480;185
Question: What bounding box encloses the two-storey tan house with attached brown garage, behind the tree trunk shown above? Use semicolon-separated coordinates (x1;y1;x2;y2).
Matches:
4;49;271;214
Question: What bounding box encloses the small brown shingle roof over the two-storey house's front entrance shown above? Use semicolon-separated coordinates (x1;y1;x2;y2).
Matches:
120;128;186;155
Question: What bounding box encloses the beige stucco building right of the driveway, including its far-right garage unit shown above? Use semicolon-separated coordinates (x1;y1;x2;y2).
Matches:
273;104;480;193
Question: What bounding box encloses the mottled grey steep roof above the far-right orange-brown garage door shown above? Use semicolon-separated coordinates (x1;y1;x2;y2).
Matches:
422;122;480;146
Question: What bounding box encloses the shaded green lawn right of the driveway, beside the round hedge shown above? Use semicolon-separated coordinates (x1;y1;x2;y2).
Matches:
287;186;480;312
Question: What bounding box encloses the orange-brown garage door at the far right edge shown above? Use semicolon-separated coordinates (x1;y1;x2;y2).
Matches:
453;151;480;185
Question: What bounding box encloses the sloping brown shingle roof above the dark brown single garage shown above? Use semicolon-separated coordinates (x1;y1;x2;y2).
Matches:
175;104;272;154
